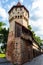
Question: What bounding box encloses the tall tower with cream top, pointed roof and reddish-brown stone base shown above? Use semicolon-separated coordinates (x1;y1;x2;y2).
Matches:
6;2;29;65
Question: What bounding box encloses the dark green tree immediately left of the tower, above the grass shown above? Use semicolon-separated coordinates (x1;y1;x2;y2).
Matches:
1;28;9;53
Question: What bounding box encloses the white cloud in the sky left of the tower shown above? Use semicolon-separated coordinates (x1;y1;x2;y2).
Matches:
0;1;9;28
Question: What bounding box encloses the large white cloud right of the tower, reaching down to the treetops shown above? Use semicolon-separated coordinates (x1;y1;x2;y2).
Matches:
29;19;43;39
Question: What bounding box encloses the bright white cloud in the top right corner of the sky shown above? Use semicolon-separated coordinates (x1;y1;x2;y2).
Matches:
32;0;43;17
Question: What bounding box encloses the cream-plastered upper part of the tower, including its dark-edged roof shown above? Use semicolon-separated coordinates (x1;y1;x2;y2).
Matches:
9;2;29;31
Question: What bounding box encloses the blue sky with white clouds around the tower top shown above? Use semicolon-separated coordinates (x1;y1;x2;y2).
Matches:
0;0;43;39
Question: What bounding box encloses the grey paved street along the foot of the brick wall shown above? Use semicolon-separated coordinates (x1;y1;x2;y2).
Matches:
23;55;43;65
